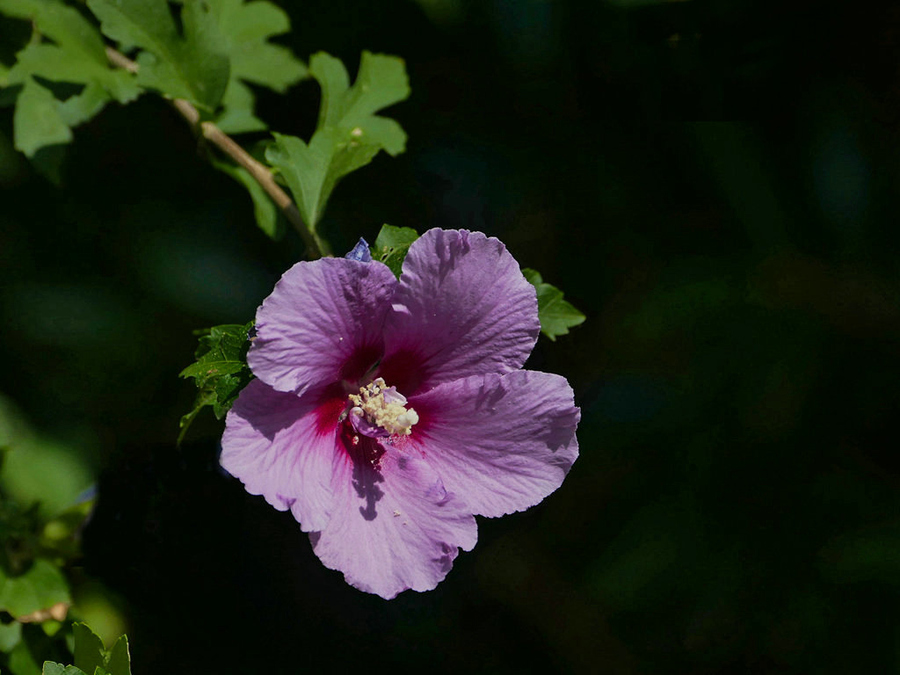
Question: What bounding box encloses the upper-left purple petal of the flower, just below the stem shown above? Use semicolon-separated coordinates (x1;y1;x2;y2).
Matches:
247;258;397;394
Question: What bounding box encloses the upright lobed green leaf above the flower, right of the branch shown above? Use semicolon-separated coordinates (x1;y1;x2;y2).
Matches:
266;52;409;232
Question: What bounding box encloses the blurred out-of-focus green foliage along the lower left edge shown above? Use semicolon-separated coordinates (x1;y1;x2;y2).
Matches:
0;397;95;675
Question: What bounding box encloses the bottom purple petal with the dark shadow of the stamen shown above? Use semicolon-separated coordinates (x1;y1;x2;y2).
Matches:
310;436;477;599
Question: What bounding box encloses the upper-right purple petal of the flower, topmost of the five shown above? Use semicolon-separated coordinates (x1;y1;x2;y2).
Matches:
381;229;540;396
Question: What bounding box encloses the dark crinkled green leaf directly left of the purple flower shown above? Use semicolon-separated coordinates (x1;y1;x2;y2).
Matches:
178;321;253;443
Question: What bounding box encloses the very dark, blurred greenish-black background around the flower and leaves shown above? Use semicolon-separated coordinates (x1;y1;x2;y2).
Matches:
0;0;900;675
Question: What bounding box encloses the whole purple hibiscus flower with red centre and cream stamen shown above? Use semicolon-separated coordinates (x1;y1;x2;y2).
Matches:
222;229;580;598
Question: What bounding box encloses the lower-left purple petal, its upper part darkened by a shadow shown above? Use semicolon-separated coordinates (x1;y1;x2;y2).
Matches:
220;380;337;532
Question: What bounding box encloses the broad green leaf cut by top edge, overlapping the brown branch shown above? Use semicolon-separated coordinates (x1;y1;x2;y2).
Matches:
88;0;229;110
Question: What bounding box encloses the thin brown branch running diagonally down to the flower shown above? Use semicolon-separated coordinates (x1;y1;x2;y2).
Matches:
106;47;327;258
